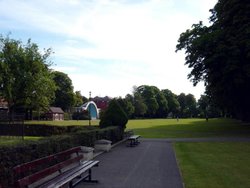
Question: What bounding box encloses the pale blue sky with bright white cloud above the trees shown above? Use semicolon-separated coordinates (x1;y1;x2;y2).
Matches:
0;0;217;100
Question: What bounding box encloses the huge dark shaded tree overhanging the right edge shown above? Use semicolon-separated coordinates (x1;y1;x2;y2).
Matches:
176;0;250;121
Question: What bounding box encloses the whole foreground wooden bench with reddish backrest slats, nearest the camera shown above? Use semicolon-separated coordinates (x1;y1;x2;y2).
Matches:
13;147;99;188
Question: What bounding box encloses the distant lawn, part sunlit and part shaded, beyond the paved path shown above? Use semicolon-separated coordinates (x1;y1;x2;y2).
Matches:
127;119;250;138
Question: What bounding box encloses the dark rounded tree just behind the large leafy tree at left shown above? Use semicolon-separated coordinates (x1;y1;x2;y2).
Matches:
52;71;75;110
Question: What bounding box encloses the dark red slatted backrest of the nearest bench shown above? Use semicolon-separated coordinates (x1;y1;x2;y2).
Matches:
13;147;83;187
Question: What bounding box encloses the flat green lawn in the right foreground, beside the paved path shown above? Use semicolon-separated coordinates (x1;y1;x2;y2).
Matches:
174;142;250;188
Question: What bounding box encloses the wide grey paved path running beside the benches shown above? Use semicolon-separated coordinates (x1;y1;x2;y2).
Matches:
77;140;183;188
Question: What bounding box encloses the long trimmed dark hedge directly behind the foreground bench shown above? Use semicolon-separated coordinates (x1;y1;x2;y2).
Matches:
0;127;123;187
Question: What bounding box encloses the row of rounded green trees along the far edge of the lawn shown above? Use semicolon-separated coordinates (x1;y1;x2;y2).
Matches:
122;85;206;118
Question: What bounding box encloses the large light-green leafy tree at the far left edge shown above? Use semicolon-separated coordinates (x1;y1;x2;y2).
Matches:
0;35;55;117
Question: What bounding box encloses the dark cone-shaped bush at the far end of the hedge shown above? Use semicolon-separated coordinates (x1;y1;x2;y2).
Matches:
100;99;128;130
